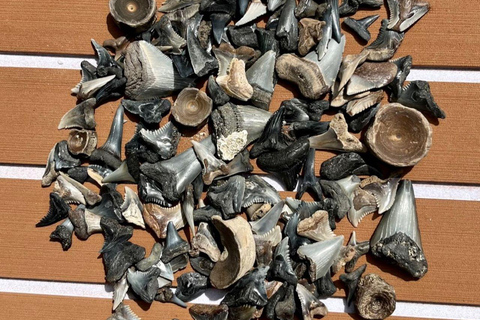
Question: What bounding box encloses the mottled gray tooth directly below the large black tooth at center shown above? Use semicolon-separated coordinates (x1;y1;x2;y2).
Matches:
242;175;281;208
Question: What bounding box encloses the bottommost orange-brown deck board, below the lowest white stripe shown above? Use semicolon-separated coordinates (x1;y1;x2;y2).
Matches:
0;293;436;320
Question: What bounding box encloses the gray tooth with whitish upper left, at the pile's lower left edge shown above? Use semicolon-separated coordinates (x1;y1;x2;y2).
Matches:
127;268;160;303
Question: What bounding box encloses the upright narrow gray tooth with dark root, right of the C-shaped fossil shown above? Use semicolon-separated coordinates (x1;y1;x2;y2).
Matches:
268;236;298;285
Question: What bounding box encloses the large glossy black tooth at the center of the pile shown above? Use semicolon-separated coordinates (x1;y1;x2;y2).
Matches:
257;138;310;190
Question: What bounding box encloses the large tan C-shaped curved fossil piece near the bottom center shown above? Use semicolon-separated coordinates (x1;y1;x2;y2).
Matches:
210;216;255;289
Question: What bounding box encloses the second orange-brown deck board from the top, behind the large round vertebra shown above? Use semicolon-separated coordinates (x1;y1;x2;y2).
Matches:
0;68;480;184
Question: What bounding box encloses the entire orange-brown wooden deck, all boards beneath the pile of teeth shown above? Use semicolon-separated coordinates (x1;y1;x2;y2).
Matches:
0;0;480;320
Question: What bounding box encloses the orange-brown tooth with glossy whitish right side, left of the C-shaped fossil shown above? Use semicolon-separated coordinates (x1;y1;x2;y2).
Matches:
143;203;186;239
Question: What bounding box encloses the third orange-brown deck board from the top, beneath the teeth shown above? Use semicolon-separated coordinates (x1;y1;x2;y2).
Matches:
0;180;480;305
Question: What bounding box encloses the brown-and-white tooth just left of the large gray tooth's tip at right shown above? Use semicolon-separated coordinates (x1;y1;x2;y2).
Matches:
360;176;400;214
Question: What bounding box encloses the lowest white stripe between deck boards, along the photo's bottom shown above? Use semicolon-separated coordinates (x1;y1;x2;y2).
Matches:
0;278;480;320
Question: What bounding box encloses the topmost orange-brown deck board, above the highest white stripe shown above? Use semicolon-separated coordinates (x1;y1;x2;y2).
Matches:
0;0;480;68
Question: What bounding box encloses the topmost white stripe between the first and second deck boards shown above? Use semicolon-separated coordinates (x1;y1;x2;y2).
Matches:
0;49;480;83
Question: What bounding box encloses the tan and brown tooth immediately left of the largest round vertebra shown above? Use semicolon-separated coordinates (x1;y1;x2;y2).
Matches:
308;113;367;152
